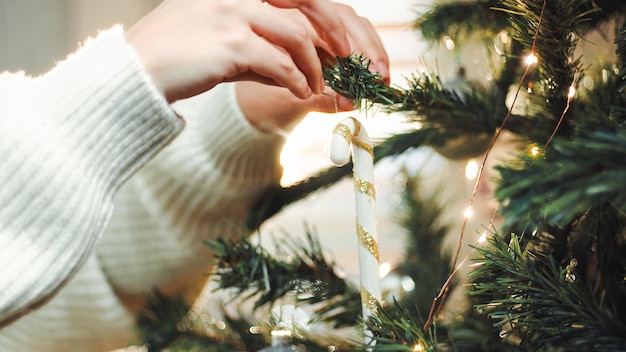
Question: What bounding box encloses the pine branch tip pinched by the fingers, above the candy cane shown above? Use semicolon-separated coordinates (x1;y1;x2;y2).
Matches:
324;55;503;139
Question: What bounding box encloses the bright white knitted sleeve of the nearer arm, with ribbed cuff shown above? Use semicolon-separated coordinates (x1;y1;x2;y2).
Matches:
0;29;183;327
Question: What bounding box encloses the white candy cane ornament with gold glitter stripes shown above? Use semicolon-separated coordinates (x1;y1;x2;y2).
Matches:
330;117;382;336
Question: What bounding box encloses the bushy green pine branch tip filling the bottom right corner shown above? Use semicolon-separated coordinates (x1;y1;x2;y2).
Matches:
470;235;626;351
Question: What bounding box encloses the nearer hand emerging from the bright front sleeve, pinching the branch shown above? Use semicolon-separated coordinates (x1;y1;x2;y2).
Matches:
126;0;350;102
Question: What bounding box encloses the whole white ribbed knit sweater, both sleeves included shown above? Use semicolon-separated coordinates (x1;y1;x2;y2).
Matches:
0;30;284;352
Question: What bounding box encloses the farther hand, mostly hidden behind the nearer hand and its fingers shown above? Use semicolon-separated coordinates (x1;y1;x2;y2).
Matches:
237;3;390;132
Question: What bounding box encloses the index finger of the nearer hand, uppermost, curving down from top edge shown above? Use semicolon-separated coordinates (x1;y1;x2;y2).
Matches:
266;0;351;57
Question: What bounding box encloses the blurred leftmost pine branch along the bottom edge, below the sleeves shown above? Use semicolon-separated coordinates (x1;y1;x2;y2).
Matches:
137;290;360;352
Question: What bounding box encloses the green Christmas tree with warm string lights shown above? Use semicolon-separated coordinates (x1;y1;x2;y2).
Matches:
134;0;626;351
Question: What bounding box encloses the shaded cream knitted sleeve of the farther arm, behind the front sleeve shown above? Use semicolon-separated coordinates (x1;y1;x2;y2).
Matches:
98;84;284;294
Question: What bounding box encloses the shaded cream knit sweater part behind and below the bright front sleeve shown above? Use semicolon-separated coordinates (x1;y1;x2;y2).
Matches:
0;50;284;352
